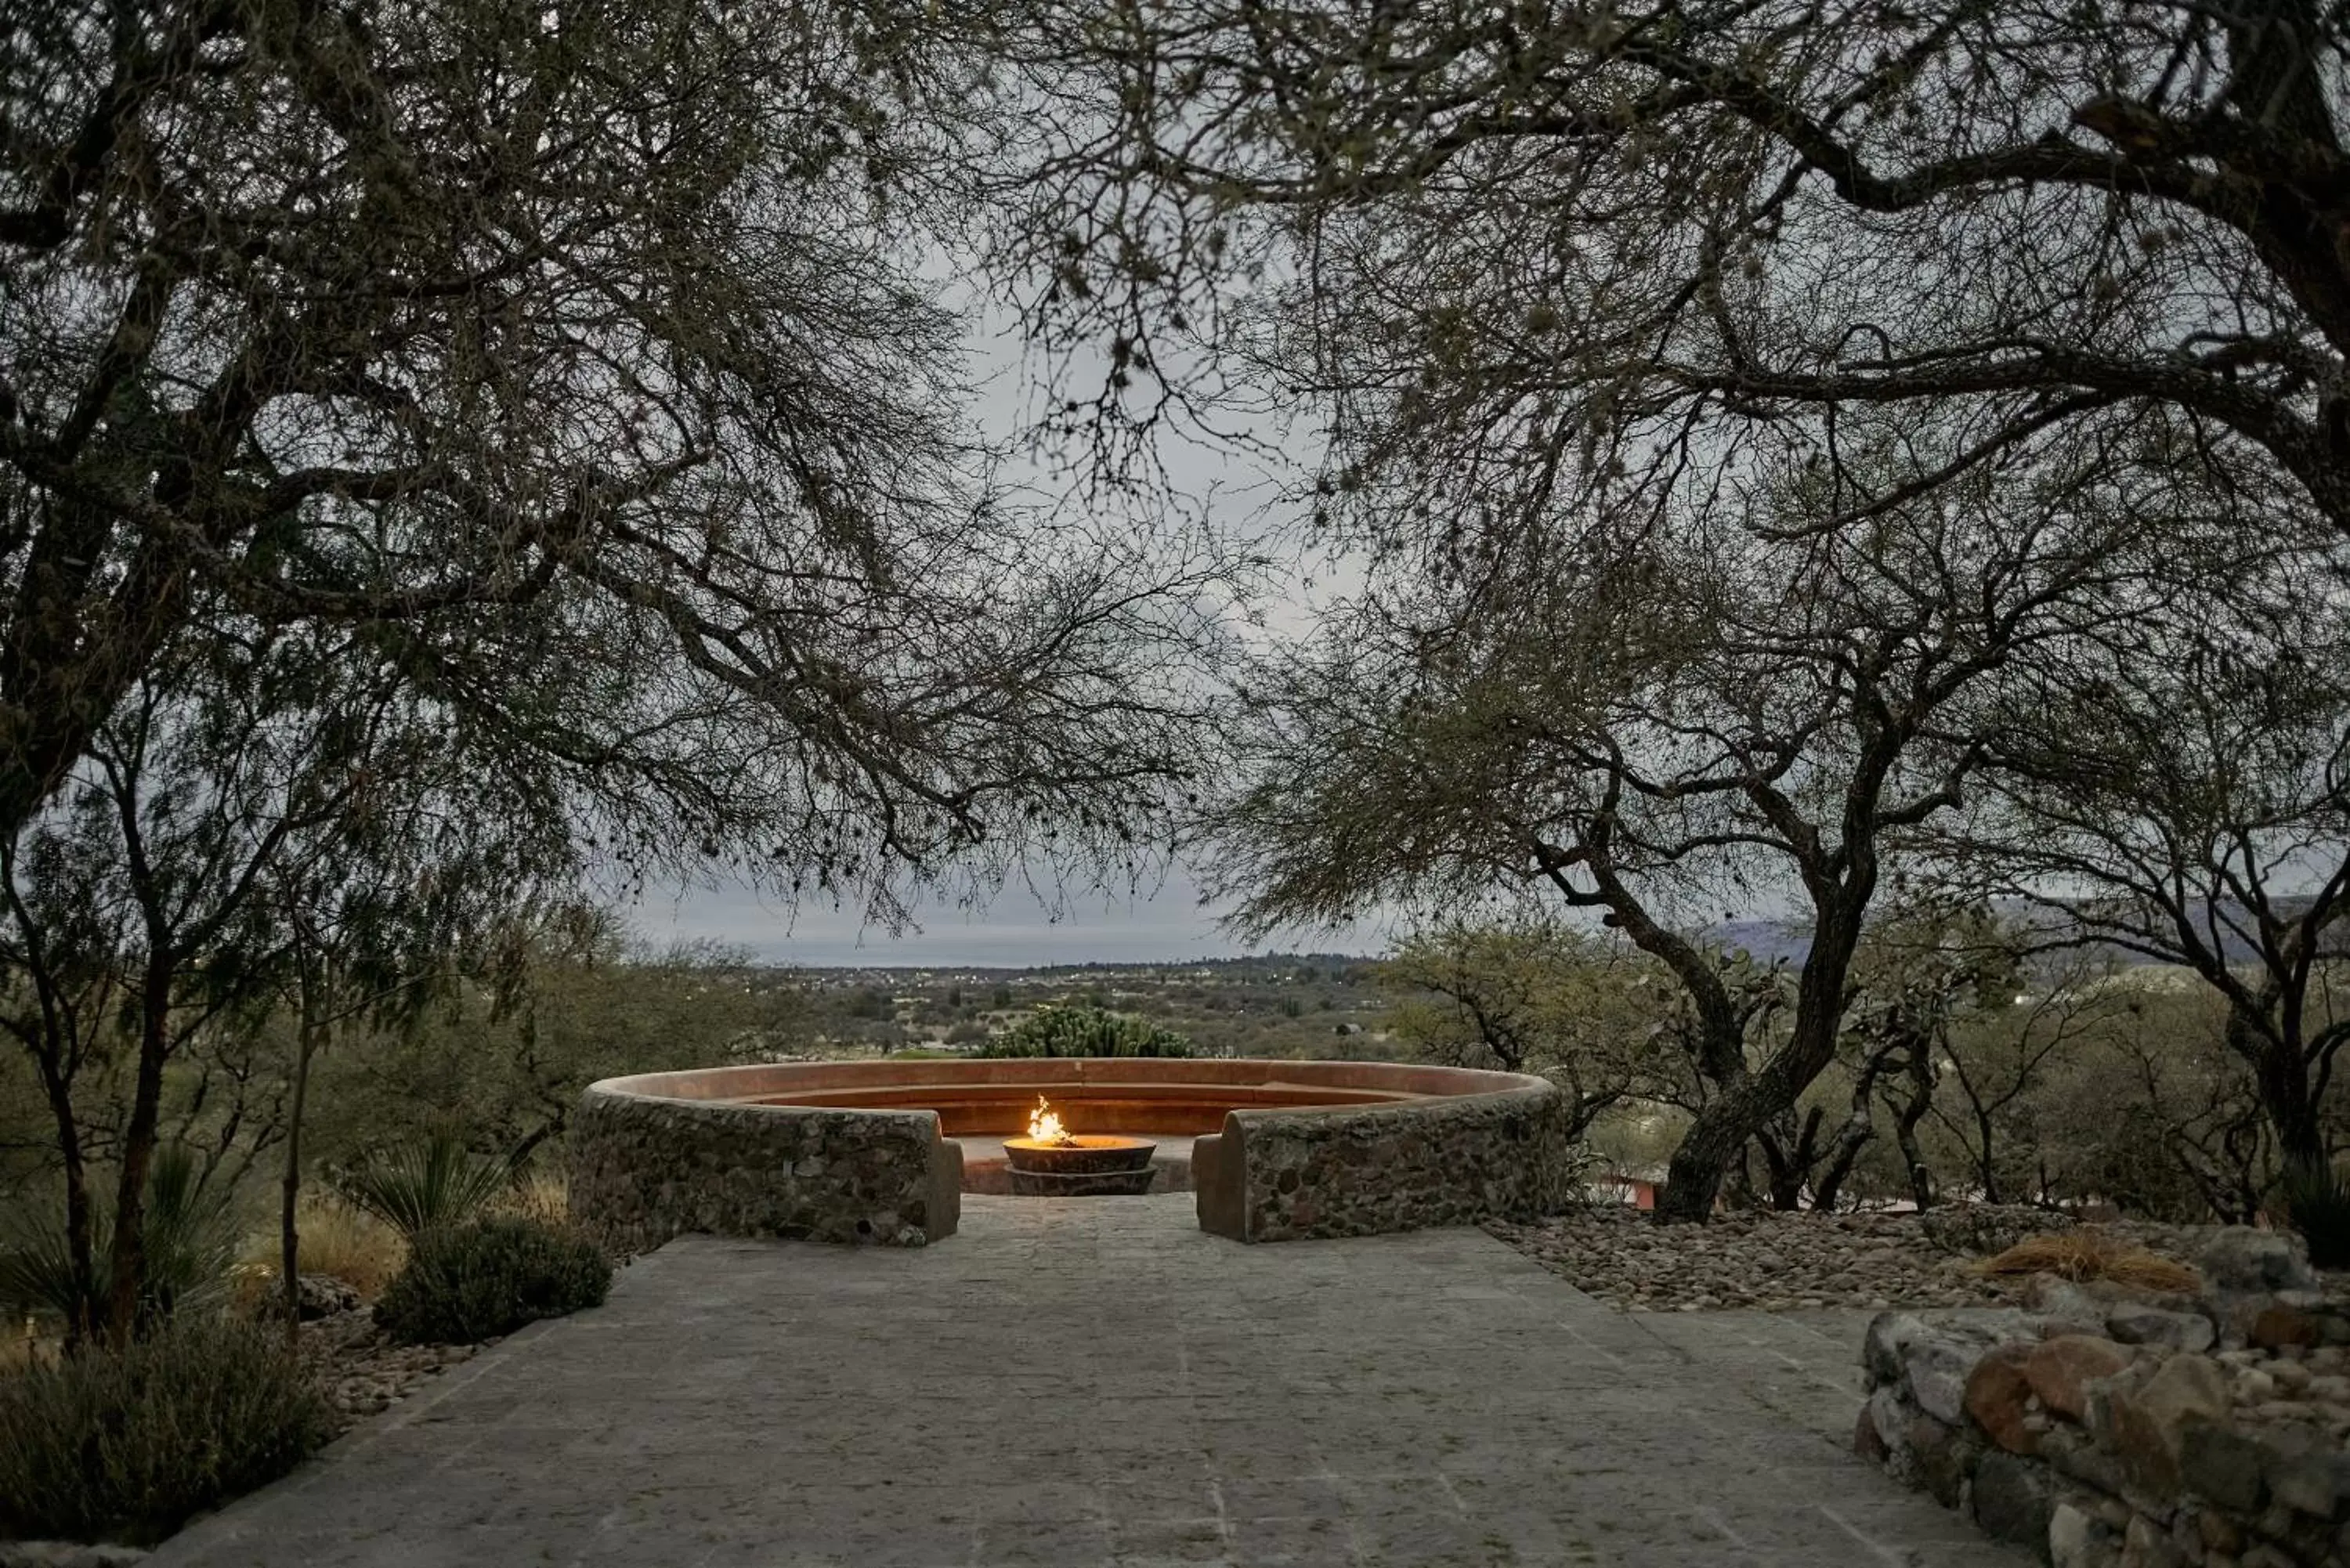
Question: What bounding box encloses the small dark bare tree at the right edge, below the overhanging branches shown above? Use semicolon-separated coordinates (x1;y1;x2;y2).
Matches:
1941;557;2350;1164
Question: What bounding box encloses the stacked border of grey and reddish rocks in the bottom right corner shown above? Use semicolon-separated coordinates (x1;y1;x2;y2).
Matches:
1854;1230;2350;1568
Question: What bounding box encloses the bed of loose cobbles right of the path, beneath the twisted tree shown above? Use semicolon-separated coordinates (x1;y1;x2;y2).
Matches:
1488;1206;2202;1312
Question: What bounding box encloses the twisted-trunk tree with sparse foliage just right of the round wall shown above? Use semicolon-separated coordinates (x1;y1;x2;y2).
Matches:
1220;442;2200;1220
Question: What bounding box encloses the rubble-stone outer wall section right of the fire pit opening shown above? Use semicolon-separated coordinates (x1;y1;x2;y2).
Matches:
1201;1084;1577;1241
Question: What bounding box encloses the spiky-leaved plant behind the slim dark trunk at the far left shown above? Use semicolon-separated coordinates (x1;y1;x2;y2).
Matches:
0;1145;237;1328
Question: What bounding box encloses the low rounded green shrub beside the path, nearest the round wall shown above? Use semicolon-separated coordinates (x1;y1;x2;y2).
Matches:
376;1220;611;1345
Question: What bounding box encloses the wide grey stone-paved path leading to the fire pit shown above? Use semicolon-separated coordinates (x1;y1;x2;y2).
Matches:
150;1197;2026;1568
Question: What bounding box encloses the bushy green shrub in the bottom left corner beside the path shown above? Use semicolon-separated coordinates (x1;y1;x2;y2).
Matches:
0;1312;334;1545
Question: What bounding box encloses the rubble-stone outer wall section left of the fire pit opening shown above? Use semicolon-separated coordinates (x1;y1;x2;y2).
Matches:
571;1086;961;1251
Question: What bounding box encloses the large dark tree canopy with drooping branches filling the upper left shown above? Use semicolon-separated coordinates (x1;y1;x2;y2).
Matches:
13;0;1208;915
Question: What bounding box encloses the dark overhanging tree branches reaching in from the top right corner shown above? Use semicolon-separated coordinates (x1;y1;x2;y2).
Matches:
1001;0;2350;540
